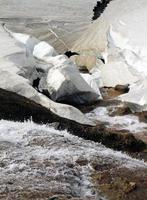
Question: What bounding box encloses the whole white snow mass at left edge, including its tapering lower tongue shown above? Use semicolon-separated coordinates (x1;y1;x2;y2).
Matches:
0;26;94;125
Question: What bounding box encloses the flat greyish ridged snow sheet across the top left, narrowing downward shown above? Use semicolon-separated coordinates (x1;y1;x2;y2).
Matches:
0;0;97;53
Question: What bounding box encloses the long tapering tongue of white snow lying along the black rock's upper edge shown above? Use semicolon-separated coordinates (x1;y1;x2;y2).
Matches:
0;71;94;125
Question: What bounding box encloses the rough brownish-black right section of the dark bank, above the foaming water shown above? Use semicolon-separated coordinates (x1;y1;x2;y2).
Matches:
60;122;146;152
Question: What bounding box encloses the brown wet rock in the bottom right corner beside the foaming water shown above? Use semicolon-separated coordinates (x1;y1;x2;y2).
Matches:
93;167;147;200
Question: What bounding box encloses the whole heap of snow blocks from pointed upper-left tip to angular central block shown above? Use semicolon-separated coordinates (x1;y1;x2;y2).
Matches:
4;26;100;104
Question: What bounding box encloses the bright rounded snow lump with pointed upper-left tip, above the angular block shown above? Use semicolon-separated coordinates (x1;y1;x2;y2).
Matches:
3;25;57;70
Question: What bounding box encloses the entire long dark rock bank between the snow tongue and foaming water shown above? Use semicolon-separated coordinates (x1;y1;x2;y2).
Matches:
0;89;146;152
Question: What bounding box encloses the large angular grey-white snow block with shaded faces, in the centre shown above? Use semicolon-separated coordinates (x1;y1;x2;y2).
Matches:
39;56;100;104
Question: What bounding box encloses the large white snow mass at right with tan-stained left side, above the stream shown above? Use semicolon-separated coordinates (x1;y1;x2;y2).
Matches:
72;0;147;112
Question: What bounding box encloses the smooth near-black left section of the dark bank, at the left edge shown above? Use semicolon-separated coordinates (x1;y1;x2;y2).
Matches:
0;89;60;123
